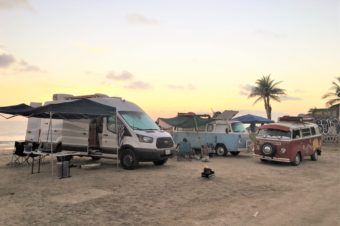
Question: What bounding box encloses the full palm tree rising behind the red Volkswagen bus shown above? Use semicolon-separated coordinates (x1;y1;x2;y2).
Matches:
248;75;286;119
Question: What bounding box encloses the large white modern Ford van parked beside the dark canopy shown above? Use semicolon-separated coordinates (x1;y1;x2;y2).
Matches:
22;94;174;169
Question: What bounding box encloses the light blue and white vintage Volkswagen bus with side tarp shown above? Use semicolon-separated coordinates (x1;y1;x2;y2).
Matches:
172;120;250;156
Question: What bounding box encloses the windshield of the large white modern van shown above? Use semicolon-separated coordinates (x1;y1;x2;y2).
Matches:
119;111;159;130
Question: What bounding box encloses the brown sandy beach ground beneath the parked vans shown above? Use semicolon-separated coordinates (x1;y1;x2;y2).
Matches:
0;145;340;226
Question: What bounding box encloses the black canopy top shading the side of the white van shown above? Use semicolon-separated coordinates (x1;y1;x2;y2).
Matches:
0;99;116;119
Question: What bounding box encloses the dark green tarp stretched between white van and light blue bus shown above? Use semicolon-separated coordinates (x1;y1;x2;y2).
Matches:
159;116;214;128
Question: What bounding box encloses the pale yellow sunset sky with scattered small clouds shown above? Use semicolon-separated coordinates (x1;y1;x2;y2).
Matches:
0;0;340;119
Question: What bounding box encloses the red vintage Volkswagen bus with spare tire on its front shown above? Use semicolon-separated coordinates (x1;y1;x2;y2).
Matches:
254;116;322;166
